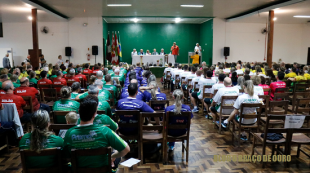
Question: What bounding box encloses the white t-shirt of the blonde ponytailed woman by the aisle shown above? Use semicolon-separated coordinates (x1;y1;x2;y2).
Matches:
234;94;261;124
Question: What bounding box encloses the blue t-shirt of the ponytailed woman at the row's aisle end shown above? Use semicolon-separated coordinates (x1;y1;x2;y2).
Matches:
165;104;193;136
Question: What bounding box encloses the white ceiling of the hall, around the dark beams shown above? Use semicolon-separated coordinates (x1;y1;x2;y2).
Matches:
0;0;310;23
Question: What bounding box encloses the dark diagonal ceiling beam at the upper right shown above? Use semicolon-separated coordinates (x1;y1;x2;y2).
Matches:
226;0;306;22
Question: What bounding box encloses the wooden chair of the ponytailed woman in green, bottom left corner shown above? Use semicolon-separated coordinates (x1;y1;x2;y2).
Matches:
20;147;62;173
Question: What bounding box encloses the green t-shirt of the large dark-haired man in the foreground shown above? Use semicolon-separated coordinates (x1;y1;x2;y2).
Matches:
64;124;127;168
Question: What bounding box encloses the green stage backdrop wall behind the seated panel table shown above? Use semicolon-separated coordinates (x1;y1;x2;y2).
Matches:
103;20;213;63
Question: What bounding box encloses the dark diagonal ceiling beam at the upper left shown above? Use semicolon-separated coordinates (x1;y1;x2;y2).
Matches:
21;0;69;19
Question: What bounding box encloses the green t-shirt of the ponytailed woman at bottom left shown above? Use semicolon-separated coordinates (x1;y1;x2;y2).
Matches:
19;133;64;168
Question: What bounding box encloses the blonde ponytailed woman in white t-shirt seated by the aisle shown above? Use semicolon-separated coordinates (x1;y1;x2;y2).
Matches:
222;80;262;141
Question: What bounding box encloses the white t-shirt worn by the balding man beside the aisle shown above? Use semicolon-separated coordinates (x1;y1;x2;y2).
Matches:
213;87;239;114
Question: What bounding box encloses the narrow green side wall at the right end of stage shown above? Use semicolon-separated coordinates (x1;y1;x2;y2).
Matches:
199;19;213;65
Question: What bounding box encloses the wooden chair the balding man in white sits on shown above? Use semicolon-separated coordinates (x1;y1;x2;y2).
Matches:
213;96;238;134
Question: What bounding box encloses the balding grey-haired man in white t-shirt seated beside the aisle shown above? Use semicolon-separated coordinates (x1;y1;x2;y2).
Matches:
210;77;239;117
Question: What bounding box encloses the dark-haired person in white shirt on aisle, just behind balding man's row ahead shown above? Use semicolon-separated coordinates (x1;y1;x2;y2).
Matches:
190;68;216;112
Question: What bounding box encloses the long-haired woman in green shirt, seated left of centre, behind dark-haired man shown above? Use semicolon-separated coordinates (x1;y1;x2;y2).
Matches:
53;86;80;124
